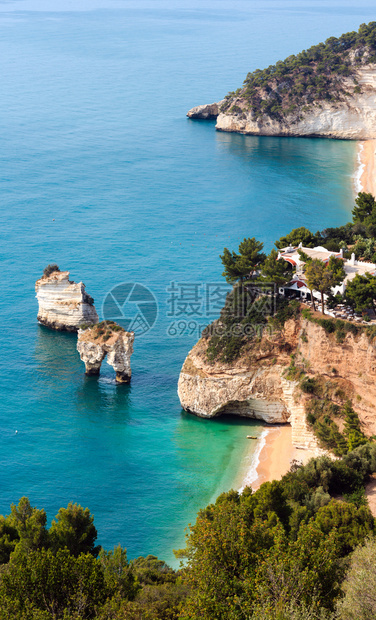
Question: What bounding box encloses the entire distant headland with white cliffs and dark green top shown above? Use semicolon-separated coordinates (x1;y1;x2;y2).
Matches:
187;22;376;140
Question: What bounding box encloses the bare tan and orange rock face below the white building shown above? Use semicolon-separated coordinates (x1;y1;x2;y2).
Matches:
178;319;376;453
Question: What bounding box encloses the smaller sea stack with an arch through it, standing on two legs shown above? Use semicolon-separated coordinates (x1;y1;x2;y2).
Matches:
77;321;134;383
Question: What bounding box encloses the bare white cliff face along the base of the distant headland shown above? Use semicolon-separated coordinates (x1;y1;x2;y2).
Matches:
188;64;376;140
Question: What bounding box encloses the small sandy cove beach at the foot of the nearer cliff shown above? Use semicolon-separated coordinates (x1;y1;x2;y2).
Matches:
240;424;316;491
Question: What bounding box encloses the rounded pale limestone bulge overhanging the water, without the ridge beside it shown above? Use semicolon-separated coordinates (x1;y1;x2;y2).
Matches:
178;321;299;423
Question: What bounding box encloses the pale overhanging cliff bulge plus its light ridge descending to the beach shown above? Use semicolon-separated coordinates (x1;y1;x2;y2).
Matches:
178;320;326;456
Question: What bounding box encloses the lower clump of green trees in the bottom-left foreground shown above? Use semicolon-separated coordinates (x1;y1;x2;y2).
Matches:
0;497;188;620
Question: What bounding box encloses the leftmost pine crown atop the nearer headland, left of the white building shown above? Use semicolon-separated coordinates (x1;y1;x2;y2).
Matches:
220;237;265;282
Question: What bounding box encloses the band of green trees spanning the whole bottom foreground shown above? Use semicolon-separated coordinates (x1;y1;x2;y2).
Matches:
0;444;376;620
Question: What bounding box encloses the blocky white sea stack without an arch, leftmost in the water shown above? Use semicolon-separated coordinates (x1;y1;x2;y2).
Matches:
35;271;99;332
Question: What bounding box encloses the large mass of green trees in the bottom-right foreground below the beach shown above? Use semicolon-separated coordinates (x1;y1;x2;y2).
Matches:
184;445;376;620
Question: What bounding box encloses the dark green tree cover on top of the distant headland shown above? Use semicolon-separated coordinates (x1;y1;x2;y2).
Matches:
222;22;376;120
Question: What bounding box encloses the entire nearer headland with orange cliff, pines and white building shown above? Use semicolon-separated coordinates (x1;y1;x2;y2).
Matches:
178;194;376;456
